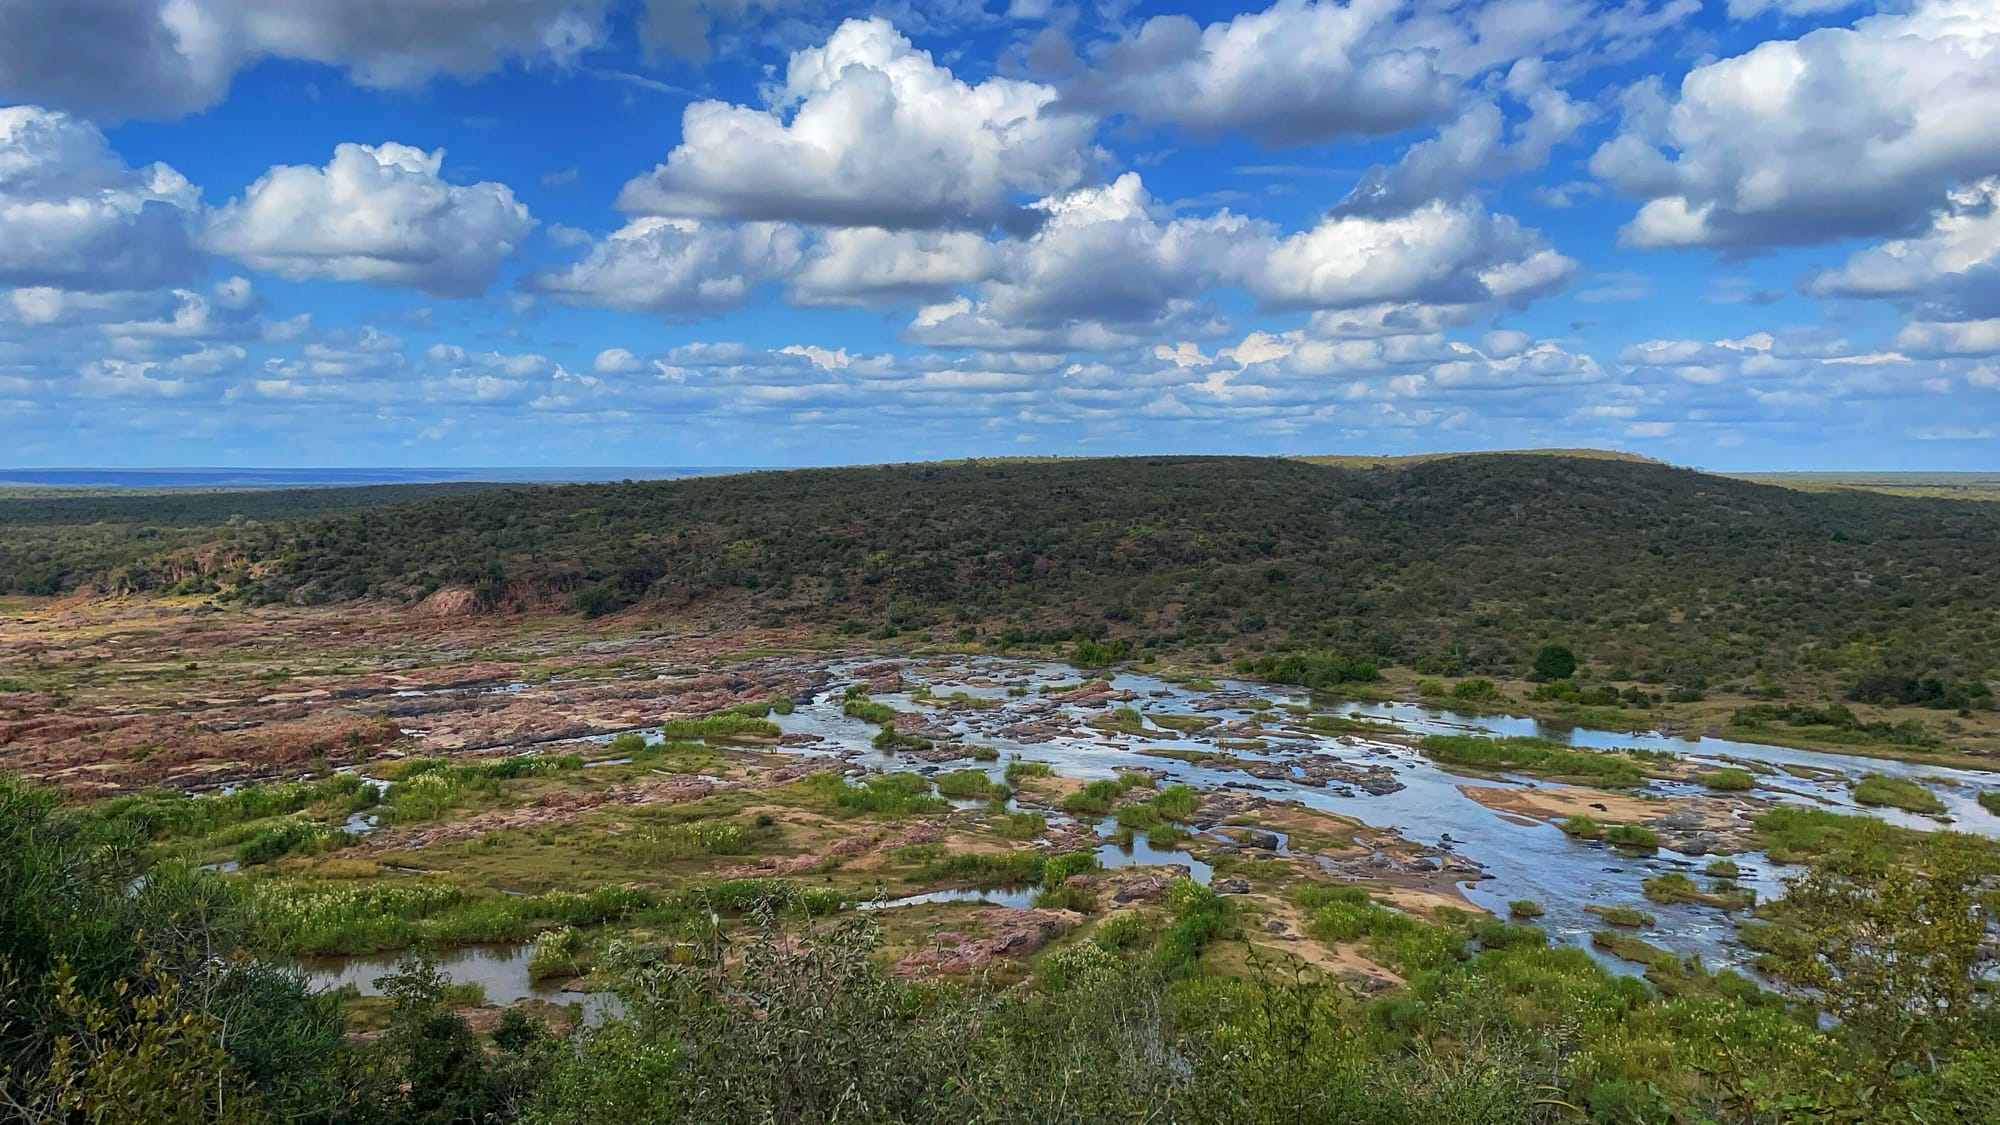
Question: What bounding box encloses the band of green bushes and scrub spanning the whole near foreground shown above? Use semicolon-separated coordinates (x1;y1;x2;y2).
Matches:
0;779;2000;1125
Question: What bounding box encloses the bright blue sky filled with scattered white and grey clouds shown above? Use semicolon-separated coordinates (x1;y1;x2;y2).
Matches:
0;0;2000;470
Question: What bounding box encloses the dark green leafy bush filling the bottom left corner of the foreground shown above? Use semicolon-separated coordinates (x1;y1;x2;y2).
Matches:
0;775;352;1123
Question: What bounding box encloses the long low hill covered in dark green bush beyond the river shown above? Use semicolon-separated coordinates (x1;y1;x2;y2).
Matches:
19;454;2000;685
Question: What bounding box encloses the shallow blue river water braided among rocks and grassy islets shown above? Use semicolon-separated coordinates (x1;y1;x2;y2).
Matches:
310;657;2000;992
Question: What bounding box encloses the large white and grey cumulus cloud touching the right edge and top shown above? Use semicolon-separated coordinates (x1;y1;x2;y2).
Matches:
1590;0;2000;246
